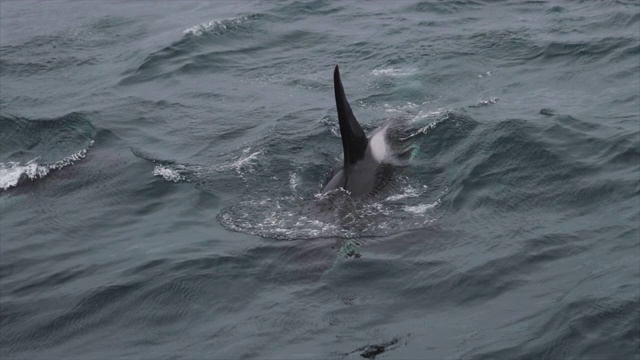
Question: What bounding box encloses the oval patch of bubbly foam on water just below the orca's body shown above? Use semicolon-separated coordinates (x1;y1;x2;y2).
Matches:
218;181;440;240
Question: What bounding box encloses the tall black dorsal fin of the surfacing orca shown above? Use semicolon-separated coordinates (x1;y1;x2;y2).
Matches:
333;65;369;166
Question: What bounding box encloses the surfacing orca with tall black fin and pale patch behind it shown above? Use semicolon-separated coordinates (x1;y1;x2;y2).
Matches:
321;65;393;197
